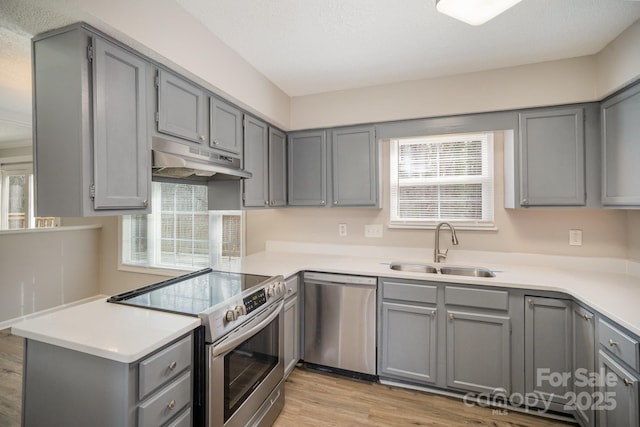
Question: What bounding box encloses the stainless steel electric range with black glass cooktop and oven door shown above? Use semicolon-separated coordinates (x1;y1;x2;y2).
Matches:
108;269;285;427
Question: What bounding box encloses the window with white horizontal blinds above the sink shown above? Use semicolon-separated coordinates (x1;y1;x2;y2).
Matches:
390;133;493;229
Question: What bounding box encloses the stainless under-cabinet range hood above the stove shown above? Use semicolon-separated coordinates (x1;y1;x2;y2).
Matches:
151;136;252;180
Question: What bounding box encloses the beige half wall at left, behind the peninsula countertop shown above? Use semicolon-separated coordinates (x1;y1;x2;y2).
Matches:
0;228;100;323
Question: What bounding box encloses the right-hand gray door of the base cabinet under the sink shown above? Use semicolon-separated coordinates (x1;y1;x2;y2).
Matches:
447;310;511;395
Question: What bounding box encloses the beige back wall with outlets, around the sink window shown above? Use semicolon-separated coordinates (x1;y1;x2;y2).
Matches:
246;135;627;258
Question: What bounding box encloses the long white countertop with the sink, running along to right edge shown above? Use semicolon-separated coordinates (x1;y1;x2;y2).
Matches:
215;242;640;336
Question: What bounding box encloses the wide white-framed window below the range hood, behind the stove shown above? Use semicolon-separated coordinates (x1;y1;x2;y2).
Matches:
122;182;242;269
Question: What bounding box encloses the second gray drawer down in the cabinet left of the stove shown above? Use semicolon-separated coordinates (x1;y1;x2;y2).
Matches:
138;372;191;427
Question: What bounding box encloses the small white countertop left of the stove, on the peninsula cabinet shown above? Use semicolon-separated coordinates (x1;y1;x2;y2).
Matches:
11;296;200;363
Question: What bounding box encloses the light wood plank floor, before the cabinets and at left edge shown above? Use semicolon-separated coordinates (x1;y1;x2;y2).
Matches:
0;330;567;427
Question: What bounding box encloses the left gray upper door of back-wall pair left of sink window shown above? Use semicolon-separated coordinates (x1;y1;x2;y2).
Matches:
287;131;327;206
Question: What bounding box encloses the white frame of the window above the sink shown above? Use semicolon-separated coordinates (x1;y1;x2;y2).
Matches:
388;131;497;231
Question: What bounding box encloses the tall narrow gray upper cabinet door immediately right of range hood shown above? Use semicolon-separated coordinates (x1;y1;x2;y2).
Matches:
243;116;269;207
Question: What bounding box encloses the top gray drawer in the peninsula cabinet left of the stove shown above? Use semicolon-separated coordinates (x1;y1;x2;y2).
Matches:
138;335;193;400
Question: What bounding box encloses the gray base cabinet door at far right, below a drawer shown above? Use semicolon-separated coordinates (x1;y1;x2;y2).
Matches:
598;350;640;427
